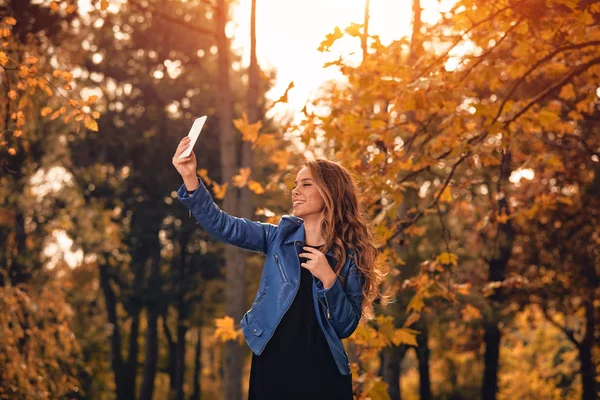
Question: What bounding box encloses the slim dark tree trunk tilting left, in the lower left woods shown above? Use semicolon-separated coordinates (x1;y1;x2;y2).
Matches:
98;265;127;400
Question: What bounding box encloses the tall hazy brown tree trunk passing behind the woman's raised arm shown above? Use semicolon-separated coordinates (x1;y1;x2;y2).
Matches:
216;0;245;400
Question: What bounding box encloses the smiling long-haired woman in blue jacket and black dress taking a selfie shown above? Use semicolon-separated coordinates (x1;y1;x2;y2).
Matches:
173;137;383;400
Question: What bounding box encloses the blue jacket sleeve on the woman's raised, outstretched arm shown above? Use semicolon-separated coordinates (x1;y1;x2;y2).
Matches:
177;177;277;254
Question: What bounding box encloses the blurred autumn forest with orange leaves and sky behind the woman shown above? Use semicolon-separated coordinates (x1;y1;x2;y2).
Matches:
0;0;600;400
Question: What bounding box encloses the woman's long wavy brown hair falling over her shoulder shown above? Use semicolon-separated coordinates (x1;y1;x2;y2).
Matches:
304;159;387;320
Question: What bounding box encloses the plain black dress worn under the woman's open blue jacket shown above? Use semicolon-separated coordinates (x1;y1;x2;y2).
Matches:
248;246;353;400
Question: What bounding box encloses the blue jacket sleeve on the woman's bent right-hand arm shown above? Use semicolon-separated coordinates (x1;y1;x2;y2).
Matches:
317;253;364;339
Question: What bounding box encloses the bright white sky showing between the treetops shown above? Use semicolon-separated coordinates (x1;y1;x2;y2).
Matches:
232;0;426;117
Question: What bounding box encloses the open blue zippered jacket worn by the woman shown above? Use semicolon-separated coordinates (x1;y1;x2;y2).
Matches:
177;178;364;375
